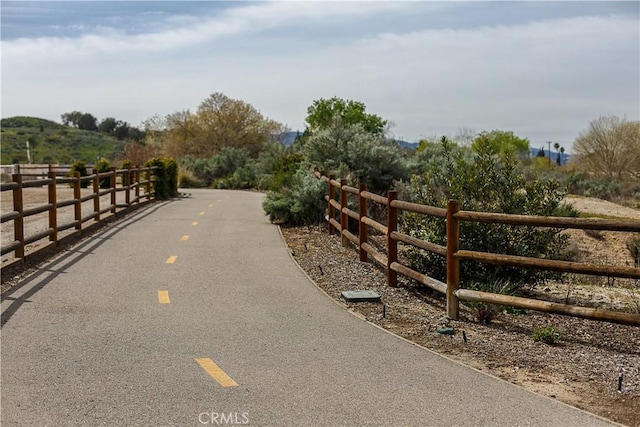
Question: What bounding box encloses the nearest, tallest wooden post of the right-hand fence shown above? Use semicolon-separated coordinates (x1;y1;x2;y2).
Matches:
447;200;460;320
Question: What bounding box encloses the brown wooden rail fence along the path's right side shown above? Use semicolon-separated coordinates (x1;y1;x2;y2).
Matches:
314;171;640;326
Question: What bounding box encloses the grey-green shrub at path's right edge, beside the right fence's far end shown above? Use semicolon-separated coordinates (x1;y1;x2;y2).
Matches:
262;163;326;225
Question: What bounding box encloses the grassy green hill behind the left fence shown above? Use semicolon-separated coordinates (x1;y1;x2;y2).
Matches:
0;116;123;165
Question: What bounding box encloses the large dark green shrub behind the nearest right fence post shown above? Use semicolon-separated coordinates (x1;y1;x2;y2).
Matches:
402;137;568;287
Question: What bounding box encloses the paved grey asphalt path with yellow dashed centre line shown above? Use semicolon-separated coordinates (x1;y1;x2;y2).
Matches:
1;190;610;426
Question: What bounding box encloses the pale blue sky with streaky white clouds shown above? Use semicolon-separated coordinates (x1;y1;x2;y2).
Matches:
1;0;640;150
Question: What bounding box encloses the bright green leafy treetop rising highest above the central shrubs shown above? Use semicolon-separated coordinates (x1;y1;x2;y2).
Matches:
306;96;388;135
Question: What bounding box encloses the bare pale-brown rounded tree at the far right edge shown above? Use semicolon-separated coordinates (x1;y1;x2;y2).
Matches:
573;116;640;179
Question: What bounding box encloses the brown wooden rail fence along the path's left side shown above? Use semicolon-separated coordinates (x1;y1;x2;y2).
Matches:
0;167;154;261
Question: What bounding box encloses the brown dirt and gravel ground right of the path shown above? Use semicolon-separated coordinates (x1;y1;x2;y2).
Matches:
282;197;640;426
